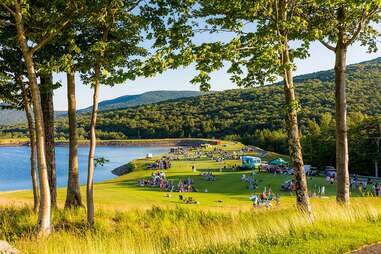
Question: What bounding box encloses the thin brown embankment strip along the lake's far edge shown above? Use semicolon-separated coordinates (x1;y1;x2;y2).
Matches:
0;138;220;147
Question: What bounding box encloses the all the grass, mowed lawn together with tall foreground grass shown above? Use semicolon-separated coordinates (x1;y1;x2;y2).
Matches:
0;140;381;253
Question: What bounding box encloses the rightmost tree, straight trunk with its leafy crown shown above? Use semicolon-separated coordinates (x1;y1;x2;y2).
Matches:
303;0;381;204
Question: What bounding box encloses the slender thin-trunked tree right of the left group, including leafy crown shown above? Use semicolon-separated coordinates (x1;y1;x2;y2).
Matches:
77;1;146;226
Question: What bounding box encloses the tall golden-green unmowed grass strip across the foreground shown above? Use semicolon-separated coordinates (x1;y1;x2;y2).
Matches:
0;199;381;254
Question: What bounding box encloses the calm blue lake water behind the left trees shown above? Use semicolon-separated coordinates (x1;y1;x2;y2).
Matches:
0;146;169;191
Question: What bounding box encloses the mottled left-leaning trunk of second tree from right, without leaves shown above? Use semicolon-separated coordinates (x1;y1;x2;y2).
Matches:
282;36;312;216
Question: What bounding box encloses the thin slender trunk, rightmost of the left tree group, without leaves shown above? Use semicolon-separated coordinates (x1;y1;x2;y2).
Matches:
86;64;100;226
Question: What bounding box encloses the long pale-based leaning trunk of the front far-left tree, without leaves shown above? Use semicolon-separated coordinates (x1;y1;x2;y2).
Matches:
15;1;51;236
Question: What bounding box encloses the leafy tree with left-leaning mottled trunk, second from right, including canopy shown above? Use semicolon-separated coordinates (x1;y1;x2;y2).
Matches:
157;0;312;215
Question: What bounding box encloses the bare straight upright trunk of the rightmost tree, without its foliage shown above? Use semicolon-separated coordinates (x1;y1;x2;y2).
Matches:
335;8;349;204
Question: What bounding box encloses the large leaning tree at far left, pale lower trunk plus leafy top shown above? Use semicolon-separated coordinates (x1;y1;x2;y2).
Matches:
1;0;75;236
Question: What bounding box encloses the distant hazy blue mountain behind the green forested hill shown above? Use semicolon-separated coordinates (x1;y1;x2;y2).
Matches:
0;90;204;125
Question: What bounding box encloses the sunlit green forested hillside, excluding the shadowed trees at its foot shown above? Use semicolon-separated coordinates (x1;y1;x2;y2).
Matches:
3;58;381;139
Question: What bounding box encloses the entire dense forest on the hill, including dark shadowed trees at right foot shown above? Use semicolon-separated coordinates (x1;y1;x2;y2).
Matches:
1;58;381;174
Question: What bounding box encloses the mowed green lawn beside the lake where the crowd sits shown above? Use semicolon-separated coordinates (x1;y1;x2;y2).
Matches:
0;142;370;211
